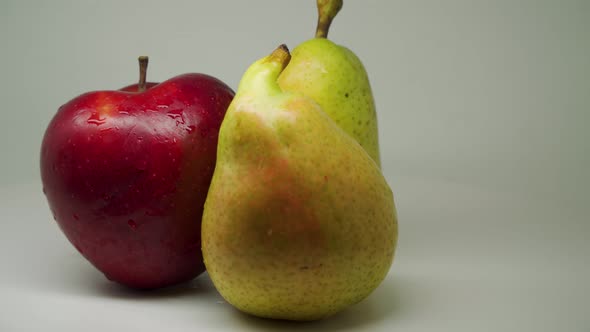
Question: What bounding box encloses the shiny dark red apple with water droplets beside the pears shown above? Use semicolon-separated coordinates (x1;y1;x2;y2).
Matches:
41;57;234;288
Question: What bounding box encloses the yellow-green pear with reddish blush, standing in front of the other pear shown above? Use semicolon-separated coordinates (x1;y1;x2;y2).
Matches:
202;47;397;320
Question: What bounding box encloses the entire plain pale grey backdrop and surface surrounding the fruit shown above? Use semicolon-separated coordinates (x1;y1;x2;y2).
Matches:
0;0;590;331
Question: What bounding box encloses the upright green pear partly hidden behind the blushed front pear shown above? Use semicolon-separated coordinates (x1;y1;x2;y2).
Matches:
278;0;380;164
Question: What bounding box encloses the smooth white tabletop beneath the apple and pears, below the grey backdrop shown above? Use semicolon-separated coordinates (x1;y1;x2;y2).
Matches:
0;172;590;332
